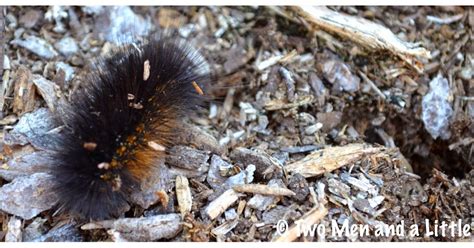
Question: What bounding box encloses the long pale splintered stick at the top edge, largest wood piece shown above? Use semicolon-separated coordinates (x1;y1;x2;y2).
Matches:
292;6;431;74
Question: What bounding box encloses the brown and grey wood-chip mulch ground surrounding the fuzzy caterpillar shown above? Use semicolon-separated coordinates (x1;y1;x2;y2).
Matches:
0;6;474;241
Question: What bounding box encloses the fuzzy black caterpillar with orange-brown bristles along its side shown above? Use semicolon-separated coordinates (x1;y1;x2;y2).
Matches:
53;37;209;219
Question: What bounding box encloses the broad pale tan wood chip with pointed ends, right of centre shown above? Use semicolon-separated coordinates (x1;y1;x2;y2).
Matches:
285;144;384;177
